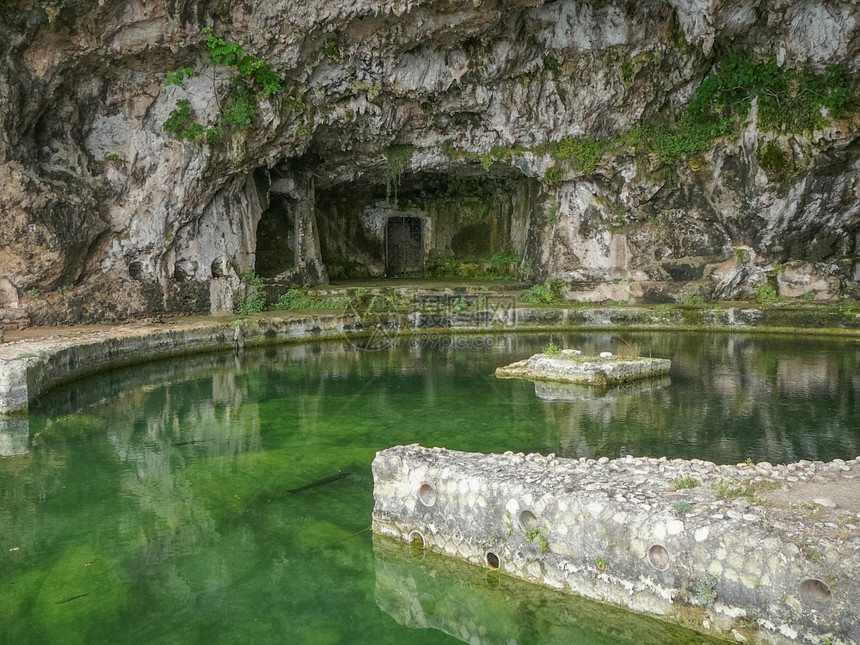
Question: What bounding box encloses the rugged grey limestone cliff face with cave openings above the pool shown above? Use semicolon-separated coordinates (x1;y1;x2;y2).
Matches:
0;0;860;323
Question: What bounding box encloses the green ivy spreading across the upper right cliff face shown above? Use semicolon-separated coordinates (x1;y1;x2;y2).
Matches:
442;55;858;181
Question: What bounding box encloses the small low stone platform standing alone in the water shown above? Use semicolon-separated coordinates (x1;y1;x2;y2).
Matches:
496;349;672;386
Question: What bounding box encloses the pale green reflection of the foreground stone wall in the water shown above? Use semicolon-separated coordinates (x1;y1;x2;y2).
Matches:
373;535;721;645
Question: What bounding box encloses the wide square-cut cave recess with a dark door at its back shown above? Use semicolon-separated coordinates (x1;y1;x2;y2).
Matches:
316;164;538;280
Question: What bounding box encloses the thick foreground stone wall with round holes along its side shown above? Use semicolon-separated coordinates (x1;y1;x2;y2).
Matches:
373;445;860;645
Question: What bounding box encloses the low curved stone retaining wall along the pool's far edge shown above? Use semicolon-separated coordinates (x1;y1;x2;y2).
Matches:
0;300;860;414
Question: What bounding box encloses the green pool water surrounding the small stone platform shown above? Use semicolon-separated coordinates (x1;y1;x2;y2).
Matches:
0;333;860;645
